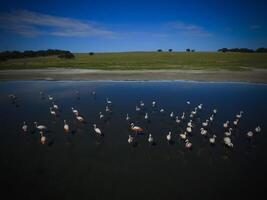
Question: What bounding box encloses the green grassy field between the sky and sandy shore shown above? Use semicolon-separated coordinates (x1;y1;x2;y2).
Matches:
0;52;267;70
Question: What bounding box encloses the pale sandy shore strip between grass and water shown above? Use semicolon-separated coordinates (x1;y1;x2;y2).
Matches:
0;68;267;83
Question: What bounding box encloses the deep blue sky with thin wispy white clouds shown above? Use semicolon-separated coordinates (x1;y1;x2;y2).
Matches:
0;0;267;52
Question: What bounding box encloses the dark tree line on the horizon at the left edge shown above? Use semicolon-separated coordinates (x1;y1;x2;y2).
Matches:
0;49;75;61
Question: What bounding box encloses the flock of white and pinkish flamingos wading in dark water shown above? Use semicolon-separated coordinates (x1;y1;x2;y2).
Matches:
8;91;261;149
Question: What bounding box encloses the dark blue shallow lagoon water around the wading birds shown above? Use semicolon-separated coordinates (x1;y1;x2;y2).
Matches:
0;81;267;199
